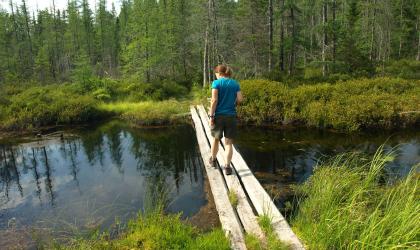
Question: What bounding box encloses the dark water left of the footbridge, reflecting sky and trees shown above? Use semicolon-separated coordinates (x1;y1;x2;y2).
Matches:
0;122;207;238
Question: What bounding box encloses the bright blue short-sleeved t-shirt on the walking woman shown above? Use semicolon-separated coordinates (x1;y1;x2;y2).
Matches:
211;77;241;116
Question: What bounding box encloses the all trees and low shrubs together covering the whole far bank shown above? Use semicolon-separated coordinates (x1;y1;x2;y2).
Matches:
0;0;420;131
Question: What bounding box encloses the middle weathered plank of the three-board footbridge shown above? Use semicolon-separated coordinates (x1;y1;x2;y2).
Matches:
197;105;265;241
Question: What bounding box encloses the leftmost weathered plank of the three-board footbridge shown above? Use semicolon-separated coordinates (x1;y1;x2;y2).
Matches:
190;106;246;250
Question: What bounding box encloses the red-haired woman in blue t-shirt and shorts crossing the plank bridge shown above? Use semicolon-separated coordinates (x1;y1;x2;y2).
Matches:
209;65;243;175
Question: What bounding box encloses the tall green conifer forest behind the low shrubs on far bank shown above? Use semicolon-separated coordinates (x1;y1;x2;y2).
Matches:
0;0;420;85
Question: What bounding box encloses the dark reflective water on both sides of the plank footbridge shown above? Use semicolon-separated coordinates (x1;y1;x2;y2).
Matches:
0;121;420;245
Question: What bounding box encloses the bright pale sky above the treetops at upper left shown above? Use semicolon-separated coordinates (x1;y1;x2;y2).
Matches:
0;0;121;12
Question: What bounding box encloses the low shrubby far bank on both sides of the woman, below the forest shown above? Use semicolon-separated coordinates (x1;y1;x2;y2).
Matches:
0;78;420;131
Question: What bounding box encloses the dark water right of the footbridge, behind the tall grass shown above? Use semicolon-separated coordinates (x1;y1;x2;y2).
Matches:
236;128;420;209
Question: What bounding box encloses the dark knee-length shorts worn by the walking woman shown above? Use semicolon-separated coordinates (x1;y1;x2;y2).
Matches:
211;115;237;139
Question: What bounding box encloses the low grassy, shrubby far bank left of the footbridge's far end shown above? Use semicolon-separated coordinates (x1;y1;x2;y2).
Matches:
0;79;193;131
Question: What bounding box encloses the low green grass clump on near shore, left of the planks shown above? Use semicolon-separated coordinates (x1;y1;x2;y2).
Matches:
59;212;230;250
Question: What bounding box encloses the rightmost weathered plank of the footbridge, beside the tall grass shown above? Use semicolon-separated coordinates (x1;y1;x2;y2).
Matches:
200;105;305;250
